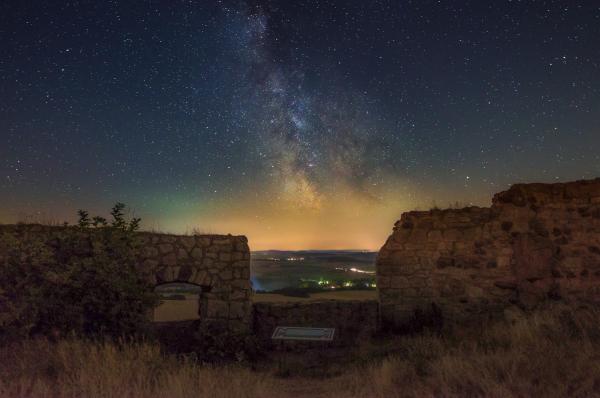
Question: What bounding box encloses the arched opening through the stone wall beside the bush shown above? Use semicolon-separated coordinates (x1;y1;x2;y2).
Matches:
153;282;202;322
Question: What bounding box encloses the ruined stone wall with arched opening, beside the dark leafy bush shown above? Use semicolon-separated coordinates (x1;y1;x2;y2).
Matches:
0;224;252;333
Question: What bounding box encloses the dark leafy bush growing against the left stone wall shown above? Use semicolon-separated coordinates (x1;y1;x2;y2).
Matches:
0;203;158;339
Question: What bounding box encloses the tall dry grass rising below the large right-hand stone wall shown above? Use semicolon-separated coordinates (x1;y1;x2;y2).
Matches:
332;308;600;397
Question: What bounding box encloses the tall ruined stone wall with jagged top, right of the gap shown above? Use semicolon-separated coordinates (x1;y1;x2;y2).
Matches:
377;179;600;328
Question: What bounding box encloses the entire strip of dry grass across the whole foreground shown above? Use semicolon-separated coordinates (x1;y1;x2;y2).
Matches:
0;308;600;397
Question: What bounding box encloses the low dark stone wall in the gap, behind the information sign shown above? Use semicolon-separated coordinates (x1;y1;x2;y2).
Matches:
254;300;378;346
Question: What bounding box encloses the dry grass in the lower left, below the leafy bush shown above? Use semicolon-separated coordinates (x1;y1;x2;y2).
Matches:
0;340;273;398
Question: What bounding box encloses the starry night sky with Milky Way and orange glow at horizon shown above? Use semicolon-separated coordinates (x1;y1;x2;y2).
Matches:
0;0;600;249
